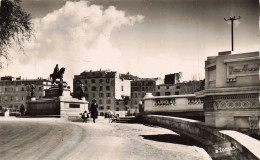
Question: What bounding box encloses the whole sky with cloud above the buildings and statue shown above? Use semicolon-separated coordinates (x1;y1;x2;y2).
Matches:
0;0;259;85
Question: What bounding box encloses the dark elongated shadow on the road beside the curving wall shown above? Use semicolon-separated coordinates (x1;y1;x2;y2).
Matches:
141;134;203;147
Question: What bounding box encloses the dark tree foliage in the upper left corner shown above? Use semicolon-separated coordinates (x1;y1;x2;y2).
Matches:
0;0;33;68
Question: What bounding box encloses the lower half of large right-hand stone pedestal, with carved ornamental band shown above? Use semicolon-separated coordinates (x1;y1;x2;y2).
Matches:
197;86;260;133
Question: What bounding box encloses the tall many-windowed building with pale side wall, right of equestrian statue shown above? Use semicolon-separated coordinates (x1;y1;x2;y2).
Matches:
73;70;131;116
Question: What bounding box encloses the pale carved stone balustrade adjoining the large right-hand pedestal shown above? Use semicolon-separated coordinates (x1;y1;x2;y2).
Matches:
143;93;203;112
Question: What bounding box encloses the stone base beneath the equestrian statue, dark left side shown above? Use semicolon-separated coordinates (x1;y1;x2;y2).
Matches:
27;84;89;121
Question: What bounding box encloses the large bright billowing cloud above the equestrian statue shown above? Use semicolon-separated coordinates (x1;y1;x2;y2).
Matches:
14;1;144;86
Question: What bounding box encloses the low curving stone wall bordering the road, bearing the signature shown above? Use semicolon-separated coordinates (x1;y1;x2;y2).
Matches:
142;115;260;160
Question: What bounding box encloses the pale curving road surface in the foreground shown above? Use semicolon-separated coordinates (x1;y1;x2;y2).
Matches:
0;119;210;160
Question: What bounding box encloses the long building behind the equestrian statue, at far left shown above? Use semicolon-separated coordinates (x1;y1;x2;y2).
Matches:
0;76;51;110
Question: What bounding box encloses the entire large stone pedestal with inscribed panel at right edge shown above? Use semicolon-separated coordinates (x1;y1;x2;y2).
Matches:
196;52;260;133
